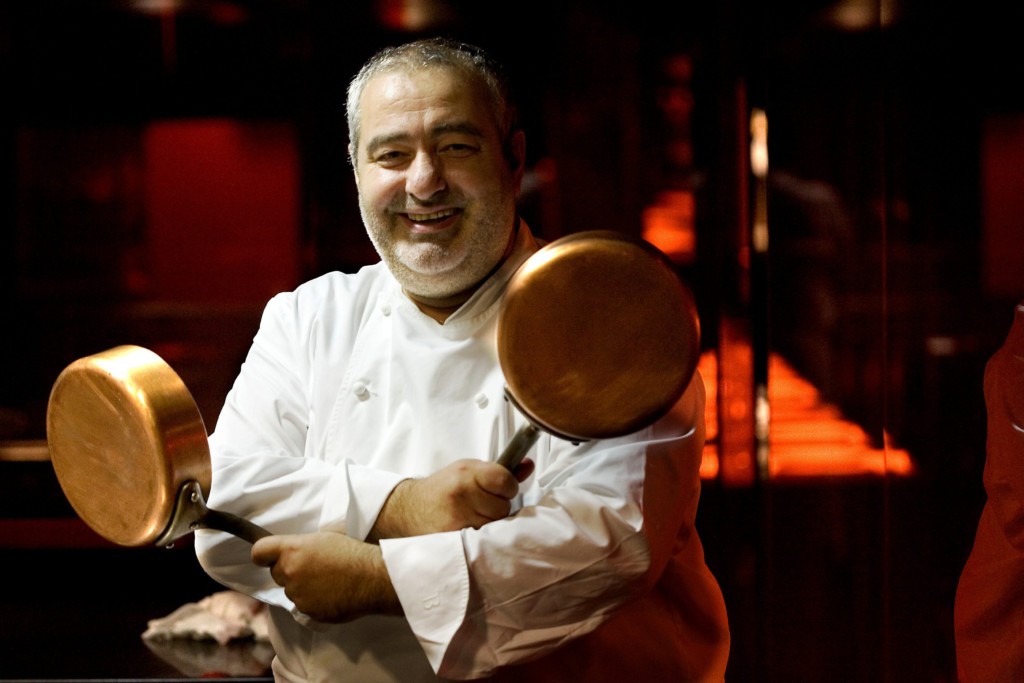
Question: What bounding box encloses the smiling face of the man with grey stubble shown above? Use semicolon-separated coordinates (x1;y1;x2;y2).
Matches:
350;69;522;298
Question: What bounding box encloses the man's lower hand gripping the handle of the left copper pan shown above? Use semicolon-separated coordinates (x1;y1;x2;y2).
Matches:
252;531;401;623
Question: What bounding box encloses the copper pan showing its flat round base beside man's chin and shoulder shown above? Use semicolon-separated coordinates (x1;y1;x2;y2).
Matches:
498;230;700;469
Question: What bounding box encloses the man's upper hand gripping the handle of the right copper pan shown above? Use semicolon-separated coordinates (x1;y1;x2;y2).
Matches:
368;459;534;541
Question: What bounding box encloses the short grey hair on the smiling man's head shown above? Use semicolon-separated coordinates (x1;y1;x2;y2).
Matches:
346;38;521;166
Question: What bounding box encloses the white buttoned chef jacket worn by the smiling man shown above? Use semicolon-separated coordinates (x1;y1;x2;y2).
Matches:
196;224;728;683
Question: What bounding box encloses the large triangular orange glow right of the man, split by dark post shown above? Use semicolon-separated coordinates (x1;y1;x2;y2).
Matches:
698;351;914;479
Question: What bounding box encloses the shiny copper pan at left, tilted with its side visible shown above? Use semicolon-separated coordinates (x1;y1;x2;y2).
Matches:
46;346;269;546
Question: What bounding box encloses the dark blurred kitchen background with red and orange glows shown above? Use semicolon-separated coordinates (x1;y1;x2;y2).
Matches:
0;0;1024;682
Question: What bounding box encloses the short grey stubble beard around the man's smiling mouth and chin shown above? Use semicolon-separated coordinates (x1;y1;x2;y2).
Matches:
359;187;515;299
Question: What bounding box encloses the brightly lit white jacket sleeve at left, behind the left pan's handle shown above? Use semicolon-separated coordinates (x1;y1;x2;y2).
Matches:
196;286;400;609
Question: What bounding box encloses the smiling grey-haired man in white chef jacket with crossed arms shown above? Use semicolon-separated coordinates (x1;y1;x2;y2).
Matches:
197;40;729;683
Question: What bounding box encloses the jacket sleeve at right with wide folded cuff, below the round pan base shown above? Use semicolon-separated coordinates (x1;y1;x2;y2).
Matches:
381;376;705;679
